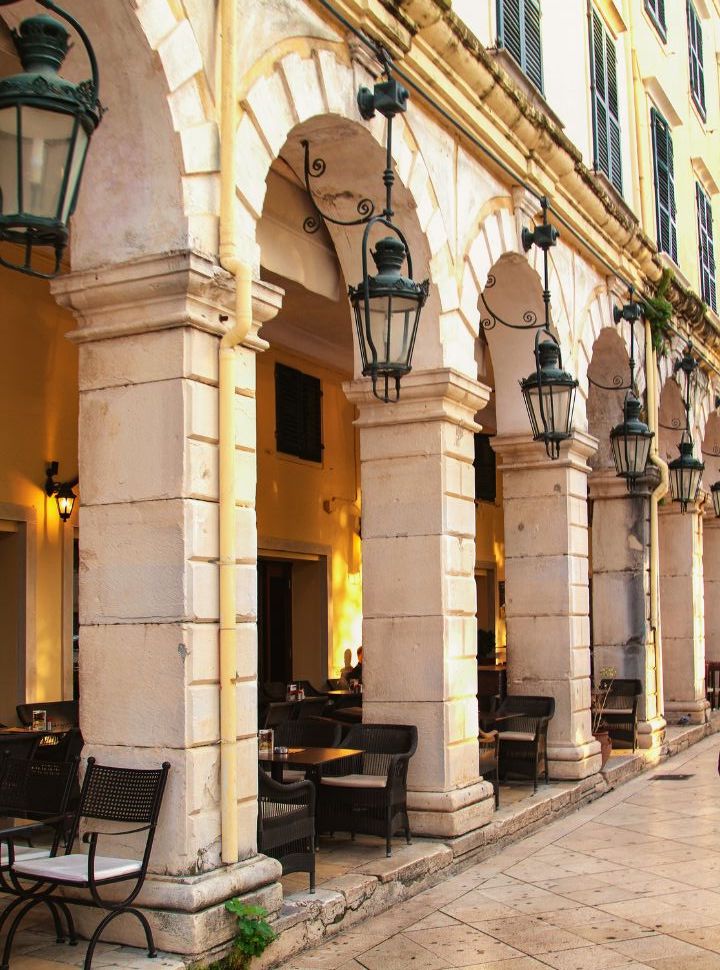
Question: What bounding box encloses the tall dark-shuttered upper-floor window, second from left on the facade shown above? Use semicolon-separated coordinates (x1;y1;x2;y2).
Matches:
590;10;622;192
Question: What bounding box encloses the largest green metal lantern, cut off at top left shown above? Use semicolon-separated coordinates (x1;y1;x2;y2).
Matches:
0;0;102;278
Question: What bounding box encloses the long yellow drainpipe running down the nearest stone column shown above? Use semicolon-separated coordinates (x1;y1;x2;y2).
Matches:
218;0;252;864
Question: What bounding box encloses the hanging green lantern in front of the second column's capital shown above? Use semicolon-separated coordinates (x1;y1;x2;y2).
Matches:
348;230;428;403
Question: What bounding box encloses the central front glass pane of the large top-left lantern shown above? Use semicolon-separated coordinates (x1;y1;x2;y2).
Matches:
20;105;75;219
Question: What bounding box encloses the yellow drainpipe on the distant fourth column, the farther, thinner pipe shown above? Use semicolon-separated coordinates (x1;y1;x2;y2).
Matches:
645;319;670;716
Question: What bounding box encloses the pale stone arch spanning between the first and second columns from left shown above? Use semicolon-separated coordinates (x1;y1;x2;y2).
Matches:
242;46;458;369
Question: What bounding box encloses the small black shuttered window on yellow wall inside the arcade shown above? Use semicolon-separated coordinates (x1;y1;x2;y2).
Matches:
275;364;323;461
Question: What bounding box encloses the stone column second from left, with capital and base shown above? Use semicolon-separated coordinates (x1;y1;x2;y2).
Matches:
346;369;493;837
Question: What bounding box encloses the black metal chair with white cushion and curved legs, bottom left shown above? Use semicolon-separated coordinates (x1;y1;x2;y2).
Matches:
1;758;170;970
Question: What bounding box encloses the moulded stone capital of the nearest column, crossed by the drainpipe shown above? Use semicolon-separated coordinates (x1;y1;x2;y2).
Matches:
51;250;283;350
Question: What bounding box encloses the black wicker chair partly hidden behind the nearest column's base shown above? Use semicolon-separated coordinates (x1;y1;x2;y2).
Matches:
257;768;315;893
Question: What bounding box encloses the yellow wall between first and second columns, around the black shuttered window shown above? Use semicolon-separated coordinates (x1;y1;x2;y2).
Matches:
257;349;362;677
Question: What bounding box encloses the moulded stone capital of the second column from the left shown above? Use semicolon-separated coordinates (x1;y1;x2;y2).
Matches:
343;367;491;432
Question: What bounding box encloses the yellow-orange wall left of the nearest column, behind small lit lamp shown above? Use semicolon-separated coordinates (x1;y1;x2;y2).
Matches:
0;258;78;701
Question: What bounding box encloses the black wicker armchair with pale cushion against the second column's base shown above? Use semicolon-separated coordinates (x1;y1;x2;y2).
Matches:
318;724;417;856
